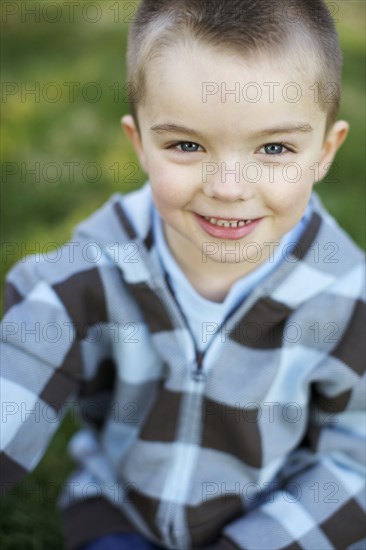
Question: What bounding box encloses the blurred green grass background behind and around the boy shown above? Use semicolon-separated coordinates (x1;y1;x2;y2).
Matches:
0;0;366;550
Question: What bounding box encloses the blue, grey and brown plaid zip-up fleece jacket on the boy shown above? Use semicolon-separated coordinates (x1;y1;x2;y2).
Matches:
1;183;365;550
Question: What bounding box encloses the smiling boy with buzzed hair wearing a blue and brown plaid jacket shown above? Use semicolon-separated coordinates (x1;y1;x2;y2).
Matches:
2;0;364;550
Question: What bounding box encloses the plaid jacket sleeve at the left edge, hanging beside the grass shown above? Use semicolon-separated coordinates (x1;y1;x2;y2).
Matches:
0;256;81;493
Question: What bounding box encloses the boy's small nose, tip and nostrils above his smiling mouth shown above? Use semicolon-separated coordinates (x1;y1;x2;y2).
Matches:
202;161;258;201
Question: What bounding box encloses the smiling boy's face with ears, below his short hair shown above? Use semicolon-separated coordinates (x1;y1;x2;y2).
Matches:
123;45;348;282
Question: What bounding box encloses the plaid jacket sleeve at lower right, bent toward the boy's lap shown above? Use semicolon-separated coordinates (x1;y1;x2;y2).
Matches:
211;300;366;550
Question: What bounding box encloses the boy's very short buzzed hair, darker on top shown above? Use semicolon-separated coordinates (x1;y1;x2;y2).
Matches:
127;0;342;137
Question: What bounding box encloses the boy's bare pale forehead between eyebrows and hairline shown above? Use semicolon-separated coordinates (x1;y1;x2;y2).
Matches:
139;45;325;132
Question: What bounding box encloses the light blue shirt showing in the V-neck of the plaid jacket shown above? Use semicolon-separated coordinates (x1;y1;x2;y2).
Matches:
153;200;313;351
